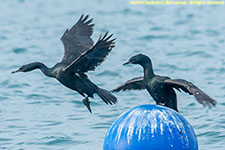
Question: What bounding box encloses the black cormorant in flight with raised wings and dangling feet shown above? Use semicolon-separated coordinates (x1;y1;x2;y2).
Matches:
12;15;117;112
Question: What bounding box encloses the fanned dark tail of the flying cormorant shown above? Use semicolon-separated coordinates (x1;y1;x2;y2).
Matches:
97;88;117;105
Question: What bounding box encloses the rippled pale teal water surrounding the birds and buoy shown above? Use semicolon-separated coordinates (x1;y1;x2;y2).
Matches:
0;0;225;150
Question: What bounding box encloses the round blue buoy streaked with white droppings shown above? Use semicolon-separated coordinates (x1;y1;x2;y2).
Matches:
103;105;198;150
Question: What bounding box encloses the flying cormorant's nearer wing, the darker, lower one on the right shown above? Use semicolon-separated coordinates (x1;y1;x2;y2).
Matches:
65;32;115;72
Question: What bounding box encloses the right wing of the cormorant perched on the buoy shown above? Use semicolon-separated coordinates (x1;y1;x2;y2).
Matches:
163;79;216;107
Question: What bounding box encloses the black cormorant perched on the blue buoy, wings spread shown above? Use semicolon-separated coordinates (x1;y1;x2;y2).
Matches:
112;54;216;111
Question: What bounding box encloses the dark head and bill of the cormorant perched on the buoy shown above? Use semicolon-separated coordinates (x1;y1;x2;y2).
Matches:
123;54;151;65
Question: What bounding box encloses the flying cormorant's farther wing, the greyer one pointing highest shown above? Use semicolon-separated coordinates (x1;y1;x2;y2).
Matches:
61;15;94;64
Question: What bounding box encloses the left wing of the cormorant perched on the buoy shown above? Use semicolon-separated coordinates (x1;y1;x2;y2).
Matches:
112;77;145;92
